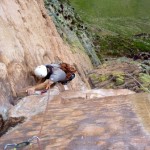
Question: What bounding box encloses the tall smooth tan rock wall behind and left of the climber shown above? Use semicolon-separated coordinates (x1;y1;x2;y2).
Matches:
0;0;92;117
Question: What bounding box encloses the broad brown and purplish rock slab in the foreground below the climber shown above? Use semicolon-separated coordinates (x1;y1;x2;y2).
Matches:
0;90;150;150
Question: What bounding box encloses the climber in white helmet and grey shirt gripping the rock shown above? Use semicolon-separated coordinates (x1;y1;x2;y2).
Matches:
26;63;76;95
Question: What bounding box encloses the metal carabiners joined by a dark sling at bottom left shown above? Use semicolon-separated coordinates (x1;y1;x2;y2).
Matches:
4;136;41;150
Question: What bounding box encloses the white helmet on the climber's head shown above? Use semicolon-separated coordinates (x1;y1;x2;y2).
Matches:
34;65;47;78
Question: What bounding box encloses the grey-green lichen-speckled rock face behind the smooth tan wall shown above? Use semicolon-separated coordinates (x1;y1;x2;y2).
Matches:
45;0;100;66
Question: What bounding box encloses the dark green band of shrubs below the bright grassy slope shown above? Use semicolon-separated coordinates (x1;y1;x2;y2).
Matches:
95;35;150;57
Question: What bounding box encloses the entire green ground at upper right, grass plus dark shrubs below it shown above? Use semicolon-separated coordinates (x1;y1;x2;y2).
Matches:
70;0;150;56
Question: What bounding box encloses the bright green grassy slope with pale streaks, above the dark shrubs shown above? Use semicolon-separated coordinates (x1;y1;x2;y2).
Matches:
70;0;150;34
